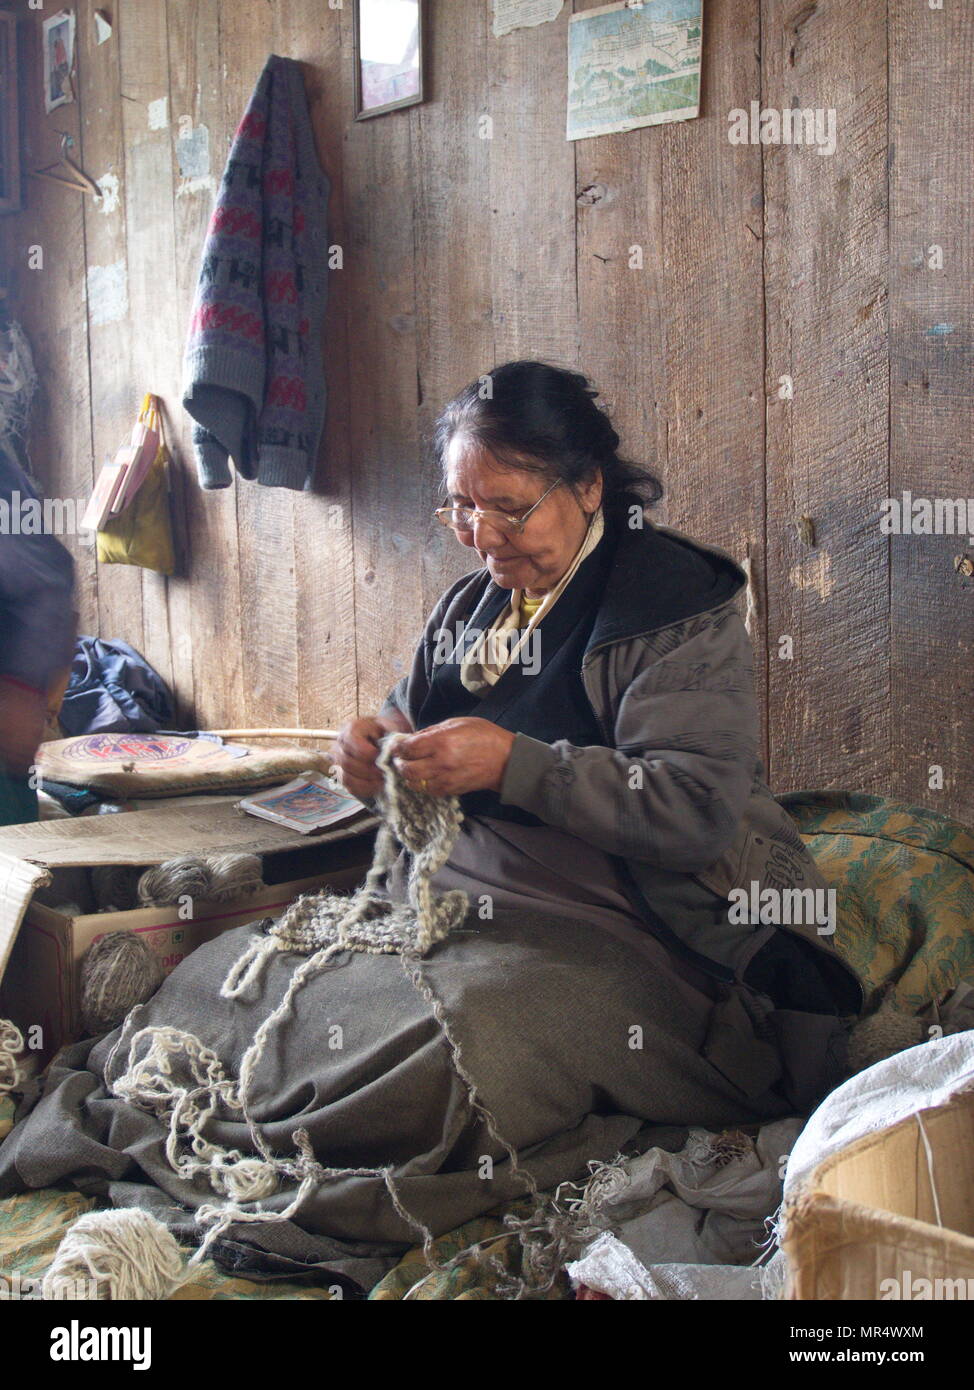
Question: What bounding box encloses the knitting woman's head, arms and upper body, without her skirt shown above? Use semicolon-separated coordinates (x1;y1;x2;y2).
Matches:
335;361;861;1034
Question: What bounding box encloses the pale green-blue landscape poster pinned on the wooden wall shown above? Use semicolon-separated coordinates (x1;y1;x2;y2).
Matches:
567;0;703;140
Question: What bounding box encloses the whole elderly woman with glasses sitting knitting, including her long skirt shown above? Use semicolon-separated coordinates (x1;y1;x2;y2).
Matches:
0;361;861;1287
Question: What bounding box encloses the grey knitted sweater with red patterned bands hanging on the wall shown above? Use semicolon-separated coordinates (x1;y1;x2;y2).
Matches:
183;56;331;491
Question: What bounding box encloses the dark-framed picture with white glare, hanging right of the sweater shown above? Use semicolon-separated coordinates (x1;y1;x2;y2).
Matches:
353;0;424;121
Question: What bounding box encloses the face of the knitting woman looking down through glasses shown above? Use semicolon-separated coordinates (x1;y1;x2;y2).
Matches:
446;435;602;596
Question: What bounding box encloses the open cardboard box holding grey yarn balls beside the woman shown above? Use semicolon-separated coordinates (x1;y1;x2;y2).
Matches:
0;798;377;1062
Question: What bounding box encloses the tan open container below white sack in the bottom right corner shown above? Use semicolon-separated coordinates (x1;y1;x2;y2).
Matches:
782;1091;974;1301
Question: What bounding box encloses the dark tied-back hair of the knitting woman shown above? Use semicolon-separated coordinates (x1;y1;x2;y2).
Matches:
432;361;663;514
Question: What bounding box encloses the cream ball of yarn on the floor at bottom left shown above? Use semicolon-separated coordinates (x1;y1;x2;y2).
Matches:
42;1207;183;1300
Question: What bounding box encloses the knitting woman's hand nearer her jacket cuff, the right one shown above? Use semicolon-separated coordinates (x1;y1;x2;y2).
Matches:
395;719;514;796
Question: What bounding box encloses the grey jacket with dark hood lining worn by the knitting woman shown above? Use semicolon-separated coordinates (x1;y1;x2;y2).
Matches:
383;521;861;995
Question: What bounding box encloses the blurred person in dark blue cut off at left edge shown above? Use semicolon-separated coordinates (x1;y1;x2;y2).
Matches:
0;446;78;826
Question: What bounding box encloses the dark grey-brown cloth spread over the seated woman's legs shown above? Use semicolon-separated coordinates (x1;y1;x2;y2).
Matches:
0;910;793;1289
